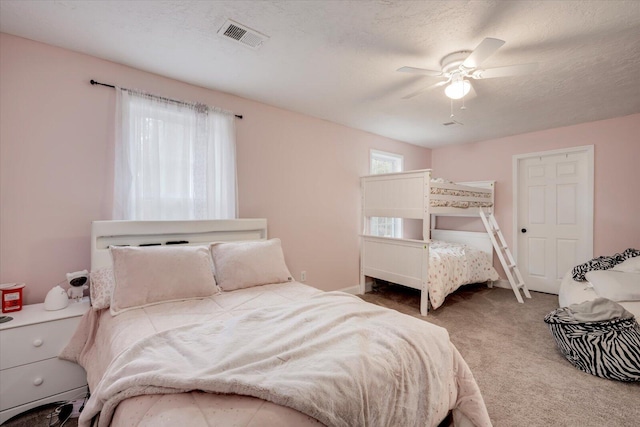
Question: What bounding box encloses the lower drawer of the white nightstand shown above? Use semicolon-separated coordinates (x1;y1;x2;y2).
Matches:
0;358;87;411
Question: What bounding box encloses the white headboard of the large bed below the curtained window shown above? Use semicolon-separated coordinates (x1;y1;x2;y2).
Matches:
91;218;267;271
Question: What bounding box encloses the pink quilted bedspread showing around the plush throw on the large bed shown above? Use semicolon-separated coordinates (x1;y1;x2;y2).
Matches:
61;282;490;427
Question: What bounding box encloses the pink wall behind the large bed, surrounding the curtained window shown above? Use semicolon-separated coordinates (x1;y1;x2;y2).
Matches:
0;34;431;303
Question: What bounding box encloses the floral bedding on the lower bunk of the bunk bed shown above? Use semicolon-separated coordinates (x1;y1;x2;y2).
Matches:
429;240;499;309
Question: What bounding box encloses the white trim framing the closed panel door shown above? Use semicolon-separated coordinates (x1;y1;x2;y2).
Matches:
511;145;595;274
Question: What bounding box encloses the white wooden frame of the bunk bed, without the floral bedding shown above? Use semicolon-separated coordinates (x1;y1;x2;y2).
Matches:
360;169;495;316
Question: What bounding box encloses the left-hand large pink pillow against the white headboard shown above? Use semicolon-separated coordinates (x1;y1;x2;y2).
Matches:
110;246;218;315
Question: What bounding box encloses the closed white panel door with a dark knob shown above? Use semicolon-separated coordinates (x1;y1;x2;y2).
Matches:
514;146;593;294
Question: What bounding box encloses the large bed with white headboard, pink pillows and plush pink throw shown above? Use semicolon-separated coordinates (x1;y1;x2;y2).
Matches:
60;219;491;427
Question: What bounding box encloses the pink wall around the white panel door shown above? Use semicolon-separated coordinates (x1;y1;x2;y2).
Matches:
432;114;640;278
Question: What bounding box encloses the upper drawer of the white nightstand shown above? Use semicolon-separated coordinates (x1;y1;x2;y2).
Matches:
0;317;80;369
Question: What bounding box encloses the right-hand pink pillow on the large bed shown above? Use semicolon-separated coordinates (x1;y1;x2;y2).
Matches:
211;239;293;291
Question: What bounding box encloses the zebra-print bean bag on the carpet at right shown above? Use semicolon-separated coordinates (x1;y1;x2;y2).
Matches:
544;298;640;381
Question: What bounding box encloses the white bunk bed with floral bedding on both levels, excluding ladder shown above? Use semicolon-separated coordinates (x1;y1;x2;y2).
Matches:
360;169;499;316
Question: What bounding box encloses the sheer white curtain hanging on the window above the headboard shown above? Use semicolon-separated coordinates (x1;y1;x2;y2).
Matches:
113;88;237;220
